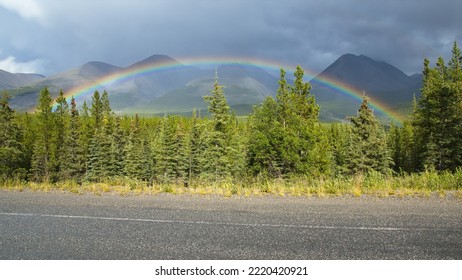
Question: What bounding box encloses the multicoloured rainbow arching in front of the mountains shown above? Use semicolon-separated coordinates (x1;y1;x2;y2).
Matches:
49;57;403;123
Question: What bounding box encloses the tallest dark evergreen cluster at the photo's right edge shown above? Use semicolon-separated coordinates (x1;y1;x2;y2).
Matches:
413;43;462;171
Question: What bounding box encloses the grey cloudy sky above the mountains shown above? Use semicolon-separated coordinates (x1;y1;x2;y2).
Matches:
0;0;462;76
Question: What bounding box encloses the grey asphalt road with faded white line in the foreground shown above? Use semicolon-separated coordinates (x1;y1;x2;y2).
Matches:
0;191;462;260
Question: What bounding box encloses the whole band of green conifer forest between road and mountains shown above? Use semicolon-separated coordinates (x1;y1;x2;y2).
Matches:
0;43;462;197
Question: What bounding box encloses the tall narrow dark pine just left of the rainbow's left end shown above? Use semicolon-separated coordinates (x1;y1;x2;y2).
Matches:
32;87;54;181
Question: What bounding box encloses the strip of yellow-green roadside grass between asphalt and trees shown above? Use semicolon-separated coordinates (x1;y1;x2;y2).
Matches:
0;170;462;200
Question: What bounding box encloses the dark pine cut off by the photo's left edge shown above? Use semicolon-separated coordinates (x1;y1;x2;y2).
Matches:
0;91;24;181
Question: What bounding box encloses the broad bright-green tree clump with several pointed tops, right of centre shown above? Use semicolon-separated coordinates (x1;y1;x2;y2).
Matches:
248;66;332;177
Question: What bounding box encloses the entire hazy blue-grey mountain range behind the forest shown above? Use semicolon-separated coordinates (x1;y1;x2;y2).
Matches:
0;54;422;121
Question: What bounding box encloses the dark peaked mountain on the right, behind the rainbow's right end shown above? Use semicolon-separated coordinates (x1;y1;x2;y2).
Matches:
311;54;422;119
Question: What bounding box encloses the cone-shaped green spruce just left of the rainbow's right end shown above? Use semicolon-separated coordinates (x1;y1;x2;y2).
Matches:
346;95;392;174
